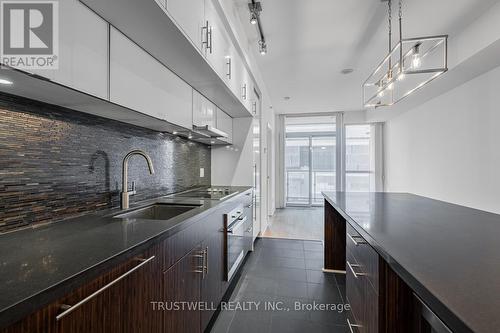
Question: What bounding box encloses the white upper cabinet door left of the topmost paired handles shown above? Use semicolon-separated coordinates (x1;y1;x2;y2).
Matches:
167;0;206;50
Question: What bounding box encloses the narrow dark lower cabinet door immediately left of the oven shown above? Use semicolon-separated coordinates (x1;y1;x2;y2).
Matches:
201;232;224;331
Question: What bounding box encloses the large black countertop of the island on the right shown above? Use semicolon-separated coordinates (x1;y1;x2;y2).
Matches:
323;192;500;333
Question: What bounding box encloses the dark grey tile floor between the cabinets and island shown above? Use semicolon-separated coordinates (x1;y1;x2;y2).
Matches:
211;238;348;333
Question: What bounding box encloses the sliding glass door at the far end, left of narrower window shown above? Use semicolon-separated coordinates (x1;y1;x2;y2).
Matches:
285;116;337;206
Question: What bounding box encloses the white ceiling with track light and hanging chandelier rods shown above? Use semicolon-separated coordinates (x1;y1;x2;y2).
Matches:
235;0;500;113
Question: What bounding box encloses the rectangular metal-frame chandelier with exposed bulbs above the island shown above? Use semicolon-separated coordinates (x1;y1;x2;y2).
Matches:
363;0;448;108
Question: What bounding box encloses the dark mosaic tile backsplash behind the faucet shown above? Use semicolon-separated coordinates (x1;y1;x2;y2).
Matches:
0;94;210;232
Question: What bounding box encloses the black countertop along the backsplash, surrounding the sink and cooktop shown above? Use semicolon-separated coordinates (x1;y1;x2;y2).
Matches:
0;186;250;327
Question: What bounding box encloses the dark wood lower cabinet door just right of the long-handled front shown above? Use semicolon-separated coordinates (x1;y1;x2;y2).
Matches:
162;247;204;333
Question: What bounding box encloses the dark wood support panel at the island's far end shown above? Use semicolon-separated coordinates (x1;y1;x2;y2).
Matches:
324;200;346;271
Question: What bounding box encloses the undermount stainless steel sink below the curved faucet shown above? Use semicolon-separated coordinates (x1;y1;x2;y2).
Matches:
114;203;201;221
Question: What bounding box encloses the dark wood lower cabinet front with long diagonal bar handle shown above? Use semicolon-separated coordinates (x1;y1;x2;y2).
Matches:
2;251;161;333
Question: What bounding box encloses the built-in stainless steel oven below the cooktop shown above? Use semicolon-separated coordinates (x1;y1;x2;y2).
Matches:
224;206;253;281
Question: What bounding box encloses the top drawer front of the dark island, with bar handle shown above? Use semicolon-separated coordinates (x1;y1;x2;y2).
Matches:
346;224;379;294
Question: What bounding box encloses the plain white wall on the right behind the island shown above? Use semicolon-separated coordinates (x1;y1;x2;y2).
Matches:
384;67;500;213
